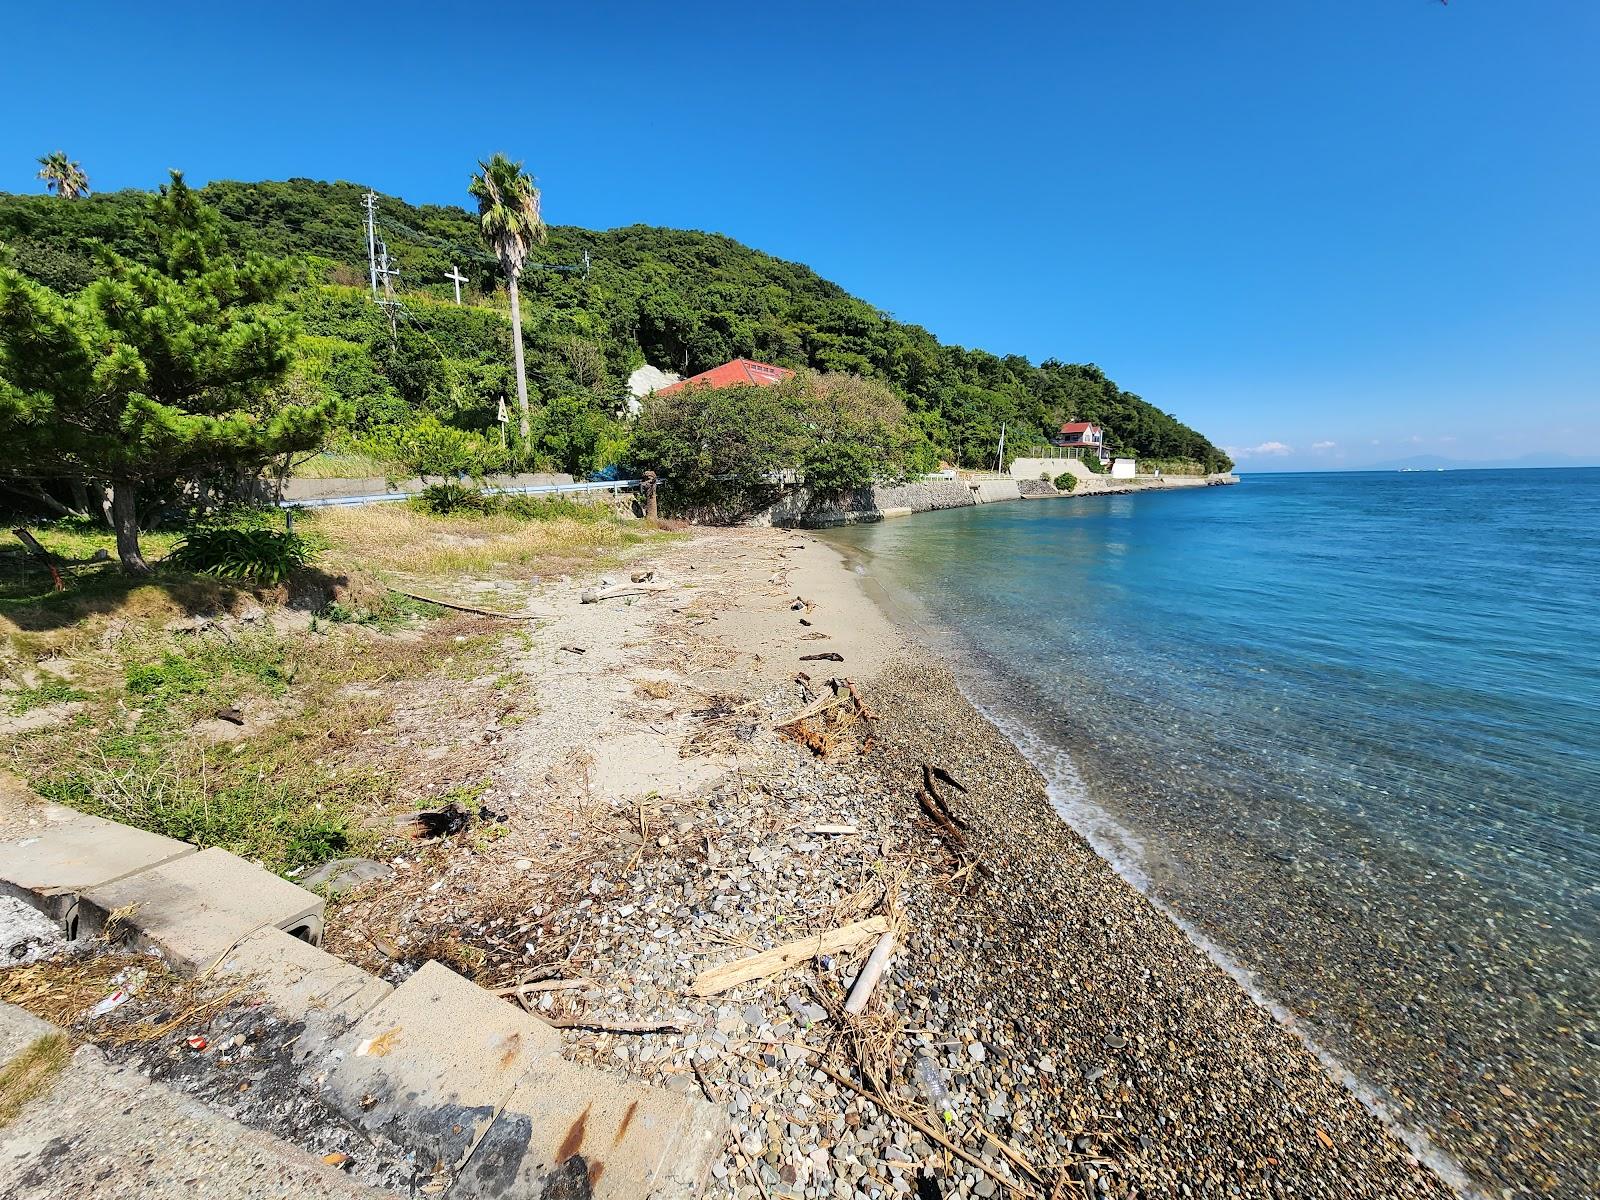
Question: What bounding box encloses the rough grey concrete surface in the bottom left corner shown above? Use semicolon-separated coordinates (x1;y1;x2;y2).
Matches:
0;1005;389;1200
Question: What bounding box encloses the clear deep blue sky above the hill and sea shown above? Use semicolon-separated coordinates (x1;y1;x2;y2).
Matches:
0;0;1600;469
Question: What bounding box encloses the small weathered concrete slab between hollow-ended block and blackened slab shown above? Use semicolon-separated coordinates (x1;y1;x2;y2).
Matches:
218;926;394;1066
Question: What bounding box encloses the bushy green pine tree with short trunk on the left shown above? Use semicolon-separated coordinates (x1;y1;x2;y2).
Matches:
0;171;336;574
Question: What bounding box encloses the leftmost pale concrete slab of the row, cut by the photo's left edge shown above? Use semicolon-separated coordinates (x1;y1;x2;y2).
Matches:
0;803;195;933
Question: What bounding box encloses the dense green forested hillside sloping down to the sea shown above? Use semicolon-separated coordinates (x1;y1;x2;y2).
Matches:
0;179;1229;470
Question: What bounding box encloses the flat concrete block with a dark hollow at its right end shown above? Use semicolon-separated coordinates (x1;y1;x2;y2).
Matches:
78;846;323;968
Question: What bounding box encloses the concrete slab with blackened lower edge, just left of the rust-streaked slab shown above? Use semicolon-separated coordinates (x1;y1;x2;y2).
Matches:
302;963;560;1179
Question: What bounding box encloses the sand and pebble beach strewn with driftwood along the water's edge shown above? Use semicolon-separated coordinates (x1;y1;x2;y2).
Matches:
302;530;1450;1198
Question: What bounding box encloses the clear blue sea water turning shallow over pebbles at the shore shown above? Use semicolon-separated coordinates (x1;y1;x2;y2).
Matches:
829;469;1600;1195
